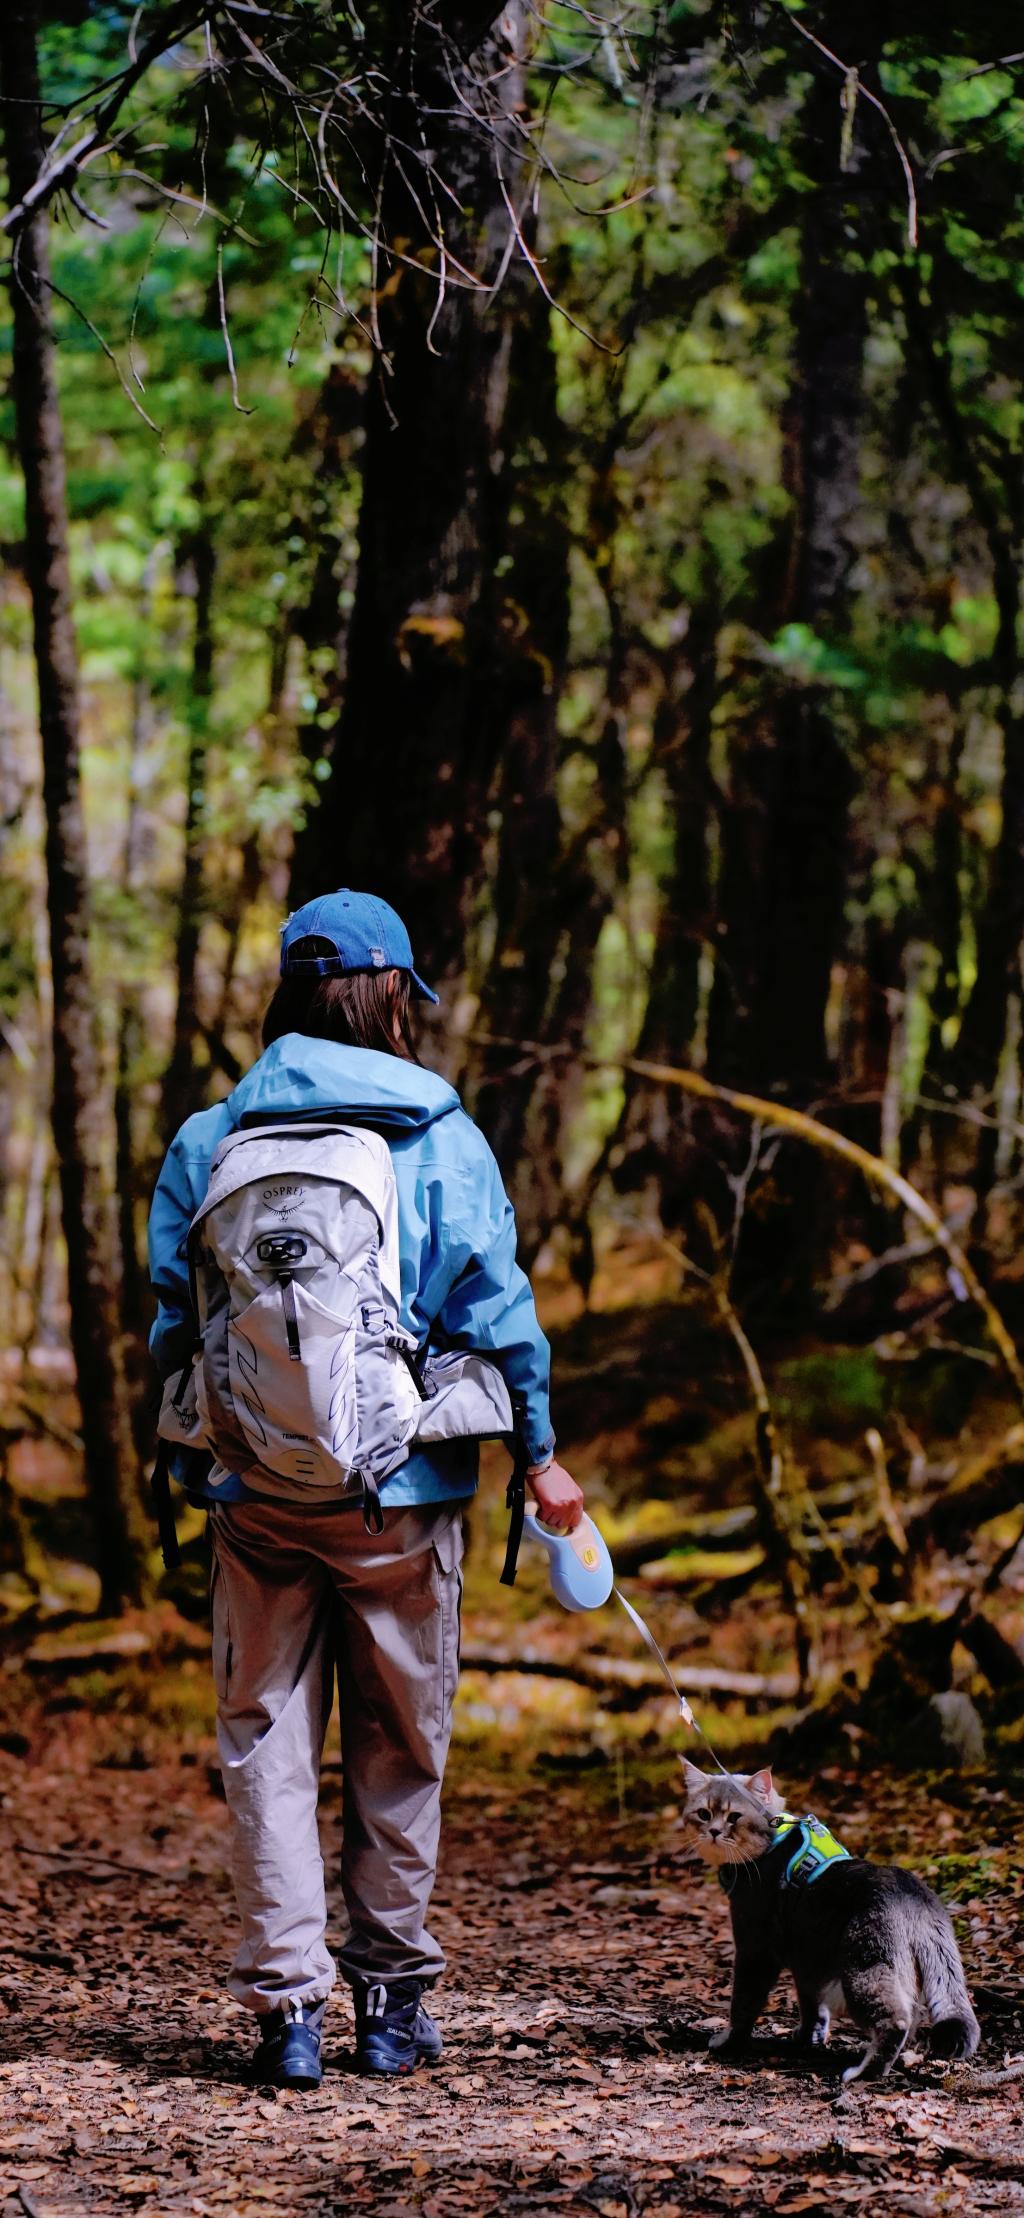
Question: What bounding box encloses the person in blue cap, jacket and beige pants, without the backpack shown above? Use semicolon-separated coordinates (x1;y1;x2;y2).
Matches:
149;887;583;2087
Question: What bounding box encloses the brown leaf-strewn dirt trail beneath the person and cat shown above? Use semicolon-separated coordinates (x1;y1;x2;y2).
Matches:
0;1750;1024;2218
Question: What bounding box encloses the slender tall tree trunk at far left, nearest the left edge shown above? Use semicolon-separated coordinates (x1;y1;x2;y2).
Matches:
0;0;144;1610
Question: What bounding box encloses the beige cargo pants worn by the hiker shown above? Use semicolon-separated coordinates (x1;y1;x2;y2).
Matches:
211;1502;463;2012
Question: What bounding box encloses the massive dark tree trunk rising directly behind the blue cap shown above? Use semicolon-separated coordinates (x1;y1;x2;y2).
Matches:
295;7;563;1029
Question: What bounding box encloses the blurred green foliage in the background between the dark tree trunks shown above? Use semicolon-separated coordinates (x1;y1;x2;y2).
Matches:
0;0;1024;1313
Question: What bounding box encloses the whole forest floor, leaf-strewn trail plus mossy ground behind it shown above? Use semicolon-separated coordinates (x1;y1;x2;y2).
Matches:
0;1311;1024;2218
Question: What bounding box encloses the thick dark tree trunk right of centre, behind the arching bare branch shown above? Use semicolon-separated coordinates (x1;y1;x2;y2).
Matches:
707;64;867;1313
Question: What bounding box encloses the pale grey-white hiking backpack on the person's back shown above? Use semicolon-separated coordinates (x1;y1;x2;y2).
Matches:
160;1120;512;1528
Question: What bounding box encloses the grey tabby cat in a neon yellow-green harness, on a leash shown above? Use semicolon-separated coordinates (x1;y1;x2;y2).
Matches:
683;1763;980;2083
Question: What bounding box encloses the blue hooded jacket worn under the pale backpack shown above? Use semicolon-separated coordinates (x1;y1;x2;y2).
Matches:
149;1031;554;1506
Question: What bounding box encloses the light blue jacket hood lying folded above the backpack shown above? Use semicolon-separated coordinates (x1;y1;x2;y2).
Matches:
226;1031;461;1131
